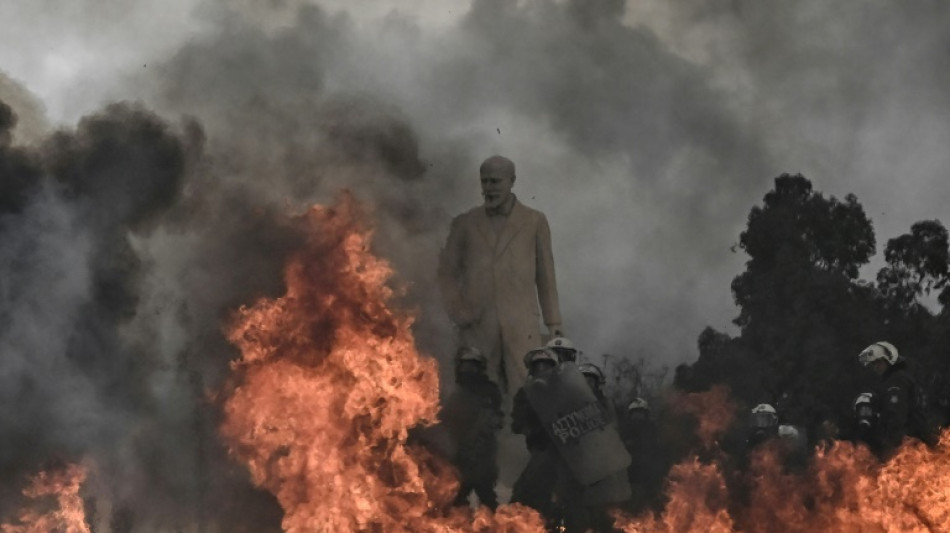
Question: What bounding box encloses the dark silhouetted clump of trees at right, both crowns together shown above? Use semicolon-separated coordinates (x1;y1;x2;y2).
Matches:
674;174;950;440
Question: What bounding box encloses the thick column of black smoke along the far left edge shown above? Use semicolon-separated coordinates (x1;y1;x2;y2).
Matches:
0;104;193;511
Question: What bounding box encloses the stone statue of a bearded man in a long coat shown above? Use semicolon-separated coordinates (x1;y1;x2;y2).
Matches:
439;156;562;394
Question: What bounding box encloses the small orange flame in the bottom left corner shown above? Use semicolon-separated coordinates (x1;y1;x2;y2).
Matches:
0;464;90;533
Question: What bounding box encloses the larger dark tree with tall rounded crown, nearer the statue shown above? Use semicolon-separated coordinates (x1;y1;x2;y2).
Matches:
681;174;883;436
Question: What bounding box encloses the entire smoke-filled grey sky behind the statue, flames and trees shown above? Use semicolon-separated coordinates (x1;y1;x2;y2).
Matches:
0;0;950;530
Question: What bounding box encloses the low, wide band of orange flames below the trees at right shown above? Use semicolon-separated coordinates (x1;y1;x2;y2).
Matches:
615;388;950;533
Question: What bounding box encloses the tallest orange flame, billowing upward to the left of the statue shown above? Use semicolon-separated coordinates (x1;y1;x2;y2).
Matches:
220;196;543;532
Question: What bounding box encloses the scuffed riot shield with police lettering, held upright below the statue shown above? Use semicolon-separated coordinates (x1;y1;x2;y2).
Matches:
524;361;630;485
